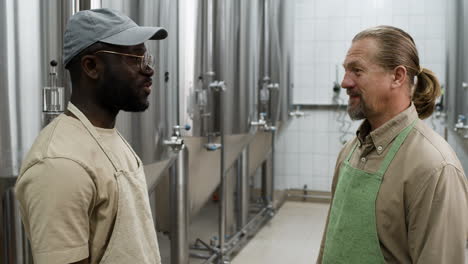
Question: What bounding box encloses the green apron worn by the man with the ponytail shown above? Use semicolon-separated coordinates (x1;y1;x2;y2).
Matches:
322;121;416;264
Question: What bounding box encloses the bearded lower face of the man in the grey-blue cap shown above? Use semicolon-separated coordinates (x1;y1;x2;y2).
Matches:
97;67;149;112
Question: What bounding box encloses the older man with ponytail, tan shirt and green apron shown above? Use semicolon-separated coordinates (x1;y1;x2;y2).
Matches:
318;26;468;264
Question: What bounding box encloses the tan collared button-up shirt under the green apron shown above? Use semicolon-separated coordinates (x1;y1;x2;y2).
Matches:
318;105;468;264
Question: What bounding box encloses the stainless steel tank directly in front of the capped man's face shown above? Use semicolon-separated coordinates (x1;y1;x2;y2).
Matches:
102;0;179;188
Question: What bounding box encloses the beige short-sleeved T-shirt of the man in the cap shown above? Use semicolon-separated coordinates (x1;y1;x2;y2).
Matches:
16;115;138;264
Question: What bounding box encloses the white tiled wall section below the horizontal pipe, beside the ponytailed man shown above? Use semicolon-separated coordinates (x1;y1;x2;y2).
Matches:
275;110;359;191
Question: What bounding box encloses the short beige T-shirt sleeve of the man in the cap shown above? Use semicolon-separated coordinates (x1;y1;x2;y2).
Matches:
16;158;96;264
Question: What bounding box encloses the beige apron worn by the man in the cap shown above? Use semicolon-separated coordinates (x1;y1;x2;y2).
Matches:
68;102;161;264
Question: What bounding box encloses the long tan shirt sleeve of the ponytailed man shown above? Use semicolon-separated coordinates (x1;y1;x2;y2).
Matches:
407;165;468;264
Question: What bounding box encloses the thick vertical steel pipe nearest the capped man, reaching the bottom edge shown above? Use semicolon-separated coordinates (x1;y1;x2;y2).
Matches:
169;145;189;264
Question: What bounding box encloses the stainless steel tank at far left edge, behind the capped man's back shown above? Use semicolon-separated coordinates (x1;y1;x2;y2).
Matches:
0;1;49;264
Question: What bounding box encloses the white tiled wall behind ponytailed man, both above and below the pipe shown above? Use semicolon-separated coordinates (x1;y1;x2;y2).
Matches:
275;0;452;191
